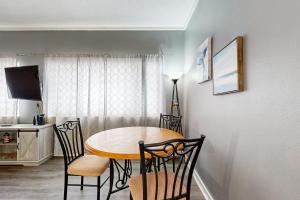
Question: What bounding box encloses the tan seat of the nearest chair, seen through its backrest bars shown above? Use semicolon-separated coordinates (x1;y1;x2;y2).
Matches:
129;172;186;200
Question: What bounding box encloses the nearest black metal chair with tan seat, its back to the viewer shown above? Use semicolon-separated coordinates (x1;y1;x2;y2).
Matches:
129;135;205;200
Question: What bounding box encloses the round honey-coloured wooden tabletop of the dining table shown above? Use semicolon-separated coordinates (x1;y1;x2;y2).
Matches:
85;127;183;160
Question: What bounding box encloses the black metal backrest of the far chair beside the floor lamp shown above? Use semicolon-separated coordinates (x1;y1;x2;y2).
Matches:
159;114;182;134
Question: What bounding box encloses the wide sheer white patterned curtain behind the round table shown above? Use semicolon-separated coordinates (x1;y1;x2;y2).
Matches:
44;55;163;155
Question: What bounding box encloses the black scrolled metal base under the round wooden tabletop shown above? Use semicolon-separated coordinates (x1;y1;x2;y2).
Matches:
106;159;132;200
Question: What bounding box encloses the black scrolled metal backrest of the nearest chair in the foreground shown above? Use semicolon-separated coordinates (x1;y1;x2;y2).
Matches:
139;135;205;200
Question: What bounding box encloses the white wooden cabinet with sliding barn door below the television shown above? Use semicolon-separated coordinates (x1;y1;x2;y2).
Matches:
0;124;54;166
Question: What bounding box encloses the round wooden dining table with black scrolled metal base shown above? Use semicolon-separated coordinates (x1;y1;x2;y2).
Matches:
85;126;183;199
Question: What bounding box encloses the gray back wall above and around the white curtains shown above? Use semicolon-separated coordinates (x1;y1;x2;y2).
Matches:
0;31;184;123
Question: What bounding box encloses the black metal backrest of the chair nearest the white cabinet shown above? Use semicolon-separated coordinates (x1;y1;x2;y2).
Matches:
53;118;84;169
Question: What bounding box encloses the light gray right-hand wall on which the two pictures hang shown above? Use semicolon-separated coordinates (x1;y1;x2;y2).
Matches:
184;0;300;200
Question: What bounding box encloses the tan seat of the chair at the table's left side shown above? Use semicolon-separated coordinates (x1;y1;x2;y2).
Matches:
68;155;109;176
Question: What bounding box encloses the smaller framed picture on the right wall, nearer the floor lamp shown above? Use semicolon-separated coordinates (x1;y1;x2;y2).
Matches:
196;37;212;83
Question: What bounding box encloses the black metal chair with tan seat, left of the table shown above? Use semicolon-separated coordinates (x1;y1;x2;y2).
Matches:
53;119;109;200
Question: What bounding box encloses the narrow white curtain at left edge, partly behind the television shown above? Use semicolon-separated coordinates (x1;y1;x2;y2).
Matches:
0;57;17;123
